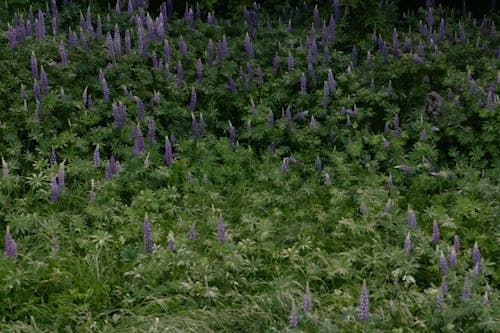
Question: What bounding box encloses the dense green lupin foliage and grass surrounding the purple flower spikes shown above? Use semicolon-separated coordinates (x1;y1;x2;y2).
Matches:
0;0;500;332
